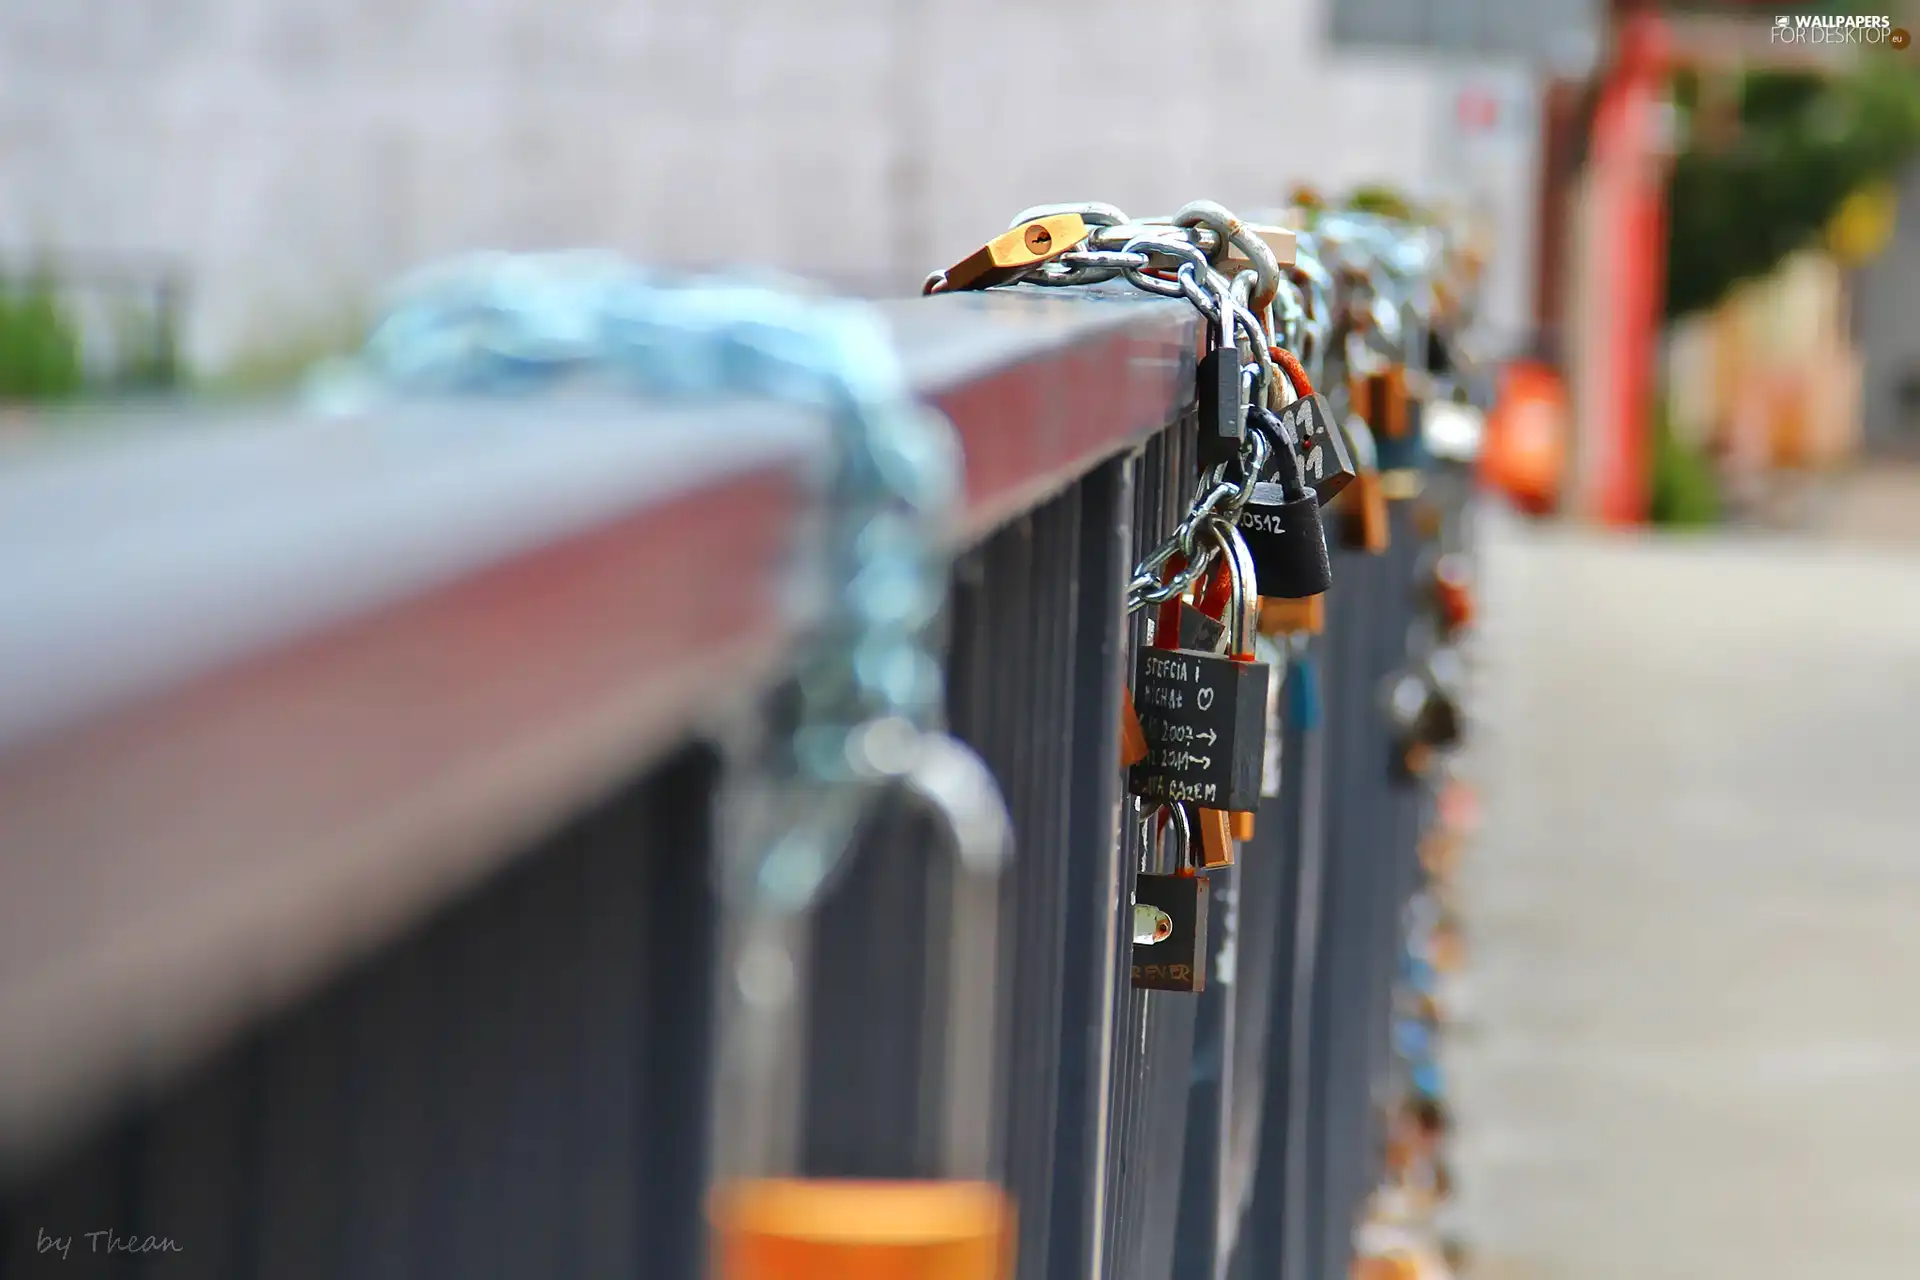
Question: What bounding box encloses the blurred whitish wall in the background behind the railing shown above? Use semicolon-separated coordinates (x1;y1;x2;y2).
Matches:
0;0;1534;367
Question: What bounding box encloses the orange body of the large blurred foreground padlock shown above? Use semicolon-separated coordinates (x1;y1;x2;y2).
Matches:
712;1178;1014;1280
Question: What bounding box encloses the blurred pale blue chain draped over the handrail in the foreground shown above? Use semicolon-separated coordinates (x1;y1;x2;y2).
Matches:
313;253;1004;912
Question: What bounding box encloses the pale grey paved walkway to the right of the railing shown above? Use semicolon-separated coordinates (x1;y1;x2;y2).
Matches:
1450;506;1920;1280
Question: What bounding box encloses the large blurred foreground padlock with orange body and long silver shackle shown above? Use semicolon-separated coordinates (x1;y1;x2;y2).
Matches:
708;729;1018;1280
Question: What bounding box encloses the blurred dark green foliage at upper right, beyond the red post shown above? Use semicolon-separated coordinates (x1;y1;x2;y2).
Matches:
1667;56;1920;319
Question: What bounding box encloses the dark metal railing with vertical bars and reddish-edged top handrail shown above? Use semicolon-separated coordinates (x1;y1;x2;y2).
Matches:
0;288;1466;1280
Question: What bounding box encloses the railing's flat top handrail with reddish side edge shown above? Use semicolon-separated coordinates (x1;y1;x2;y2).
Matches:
0;288;1198;1161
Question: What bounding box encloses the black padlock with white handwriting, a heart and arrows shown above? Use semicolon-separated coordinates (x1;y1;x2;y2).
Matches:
1127;524;1269;814
